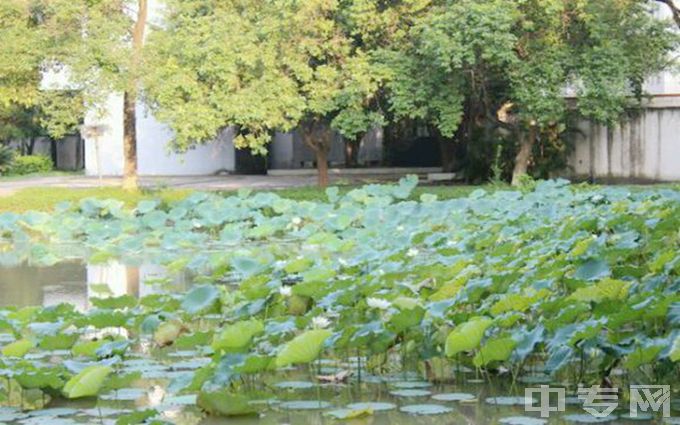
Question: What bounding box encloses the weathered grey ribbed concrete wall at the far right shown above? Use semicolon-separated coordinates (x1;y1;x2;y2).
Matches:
569;95;680;181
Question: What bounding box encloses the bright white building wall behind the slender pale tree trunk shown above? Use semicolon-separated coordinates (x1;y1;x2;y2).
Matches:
85;94;235;176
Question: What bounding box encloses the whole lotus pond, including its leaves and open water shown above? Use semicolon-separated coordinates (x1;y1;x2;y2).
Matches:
0;178;680;425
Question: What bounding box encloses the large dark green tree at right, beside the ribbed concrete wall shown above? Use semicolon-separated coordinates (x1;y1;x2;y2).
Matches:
384;0;676;182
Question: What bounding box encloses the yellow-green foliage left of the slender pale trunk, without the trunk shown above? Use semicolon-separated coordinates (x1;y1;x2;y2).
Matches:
0;0;127;138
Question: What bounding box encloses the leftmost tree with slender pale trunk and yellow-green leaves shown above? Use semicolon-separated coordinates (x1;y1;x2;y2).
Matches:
0;0;147;189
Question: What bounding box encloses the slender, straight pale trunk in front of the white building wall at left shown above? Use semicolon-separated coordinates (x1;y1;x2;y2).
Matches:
123;0;148;190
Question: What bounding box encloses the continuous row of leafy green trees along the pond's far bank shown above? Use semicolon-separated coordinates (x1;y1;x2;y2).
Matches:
0;0;678;186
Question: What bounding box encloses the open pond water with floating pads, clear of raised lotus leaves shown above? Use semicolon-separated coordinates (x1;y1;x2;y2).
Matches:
0;260;675;425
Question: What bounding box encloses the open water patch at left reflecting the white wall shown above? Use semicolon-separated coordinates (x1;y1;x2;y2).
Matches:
0;261;190;310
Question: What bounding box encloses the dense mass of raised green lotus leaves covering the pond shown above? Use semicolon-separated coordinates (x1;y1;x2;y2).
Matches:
0;178;680;415
